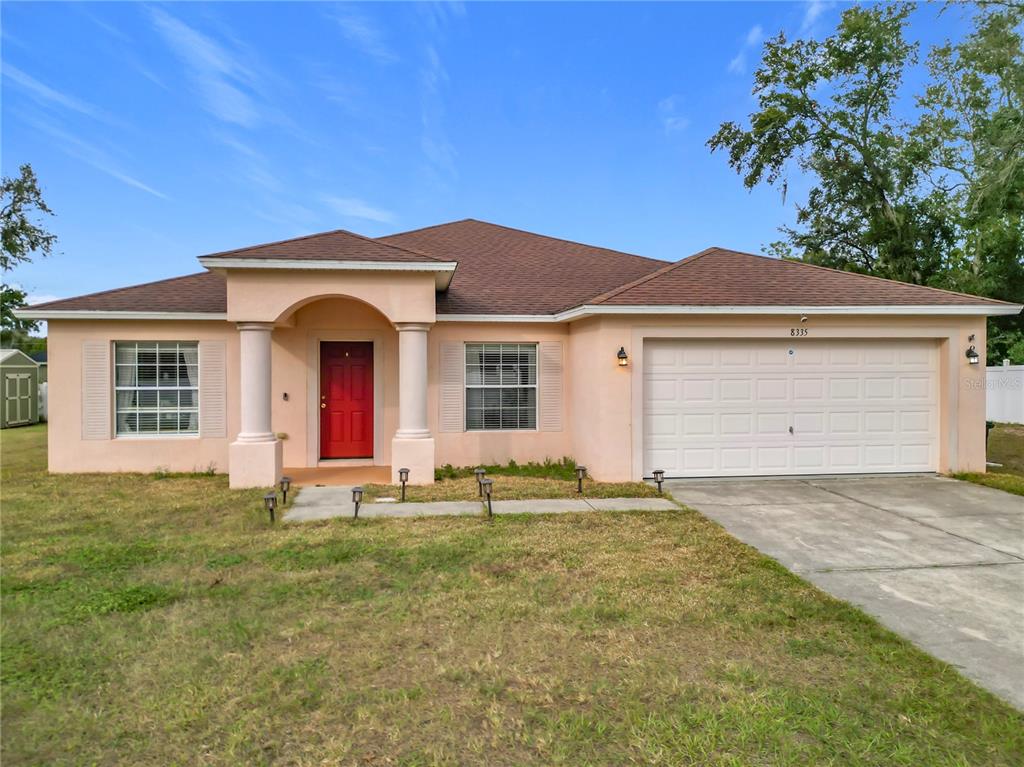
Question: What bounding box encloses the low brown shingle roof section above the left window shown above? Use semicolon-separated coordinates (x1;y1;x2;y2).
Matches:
30;271;227;312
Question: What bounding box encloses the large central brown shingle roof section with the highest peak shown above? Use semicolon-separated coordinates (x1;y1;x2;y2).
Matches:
381;218;666;314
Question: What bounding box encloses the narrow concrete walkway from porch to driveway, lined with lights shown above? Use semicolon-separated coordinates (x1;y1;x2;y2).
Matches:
284;485;679;522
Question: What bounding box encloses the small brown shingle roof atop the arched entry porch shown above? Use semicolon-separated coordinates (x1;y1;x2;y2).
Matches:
203;229;440;262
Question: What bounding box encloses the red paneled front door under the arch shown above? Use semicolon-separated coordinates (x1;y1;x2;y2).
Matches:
319;341;374;458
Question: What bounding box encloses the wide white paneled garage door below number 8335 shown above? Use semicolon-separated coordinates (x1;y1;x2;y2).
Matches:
643;339;939;477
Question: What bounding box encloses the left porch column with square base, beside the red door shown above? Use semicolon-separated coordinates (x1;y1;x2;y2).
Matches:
227;323;282;487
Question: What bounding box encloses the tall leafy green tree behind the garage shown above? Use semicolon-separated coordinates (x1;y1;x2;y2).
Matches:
709;4;1024;361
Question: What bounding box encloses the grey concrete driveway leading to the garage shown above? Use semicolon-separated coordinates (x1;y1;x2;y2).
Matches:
666;476;1024;709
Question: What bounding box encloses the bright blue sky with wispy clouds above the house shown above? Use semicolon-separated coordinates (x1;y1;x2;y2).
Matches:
0;2;963;300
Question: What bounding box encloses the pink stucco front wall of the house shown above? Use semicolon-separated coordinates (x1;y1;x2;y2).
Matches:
49;307;985;480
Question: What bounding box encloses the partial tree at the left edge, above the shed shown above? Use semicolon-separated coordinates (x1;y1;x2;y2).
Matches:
0;164;56;345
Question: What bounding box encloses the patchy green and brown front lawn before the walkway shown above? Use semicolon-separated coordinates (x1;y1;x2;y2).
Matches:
6;427;1024;767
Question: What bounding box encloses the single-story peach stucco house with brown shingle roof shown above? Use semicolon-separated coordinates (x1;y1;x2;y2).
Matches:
19;219;1022;487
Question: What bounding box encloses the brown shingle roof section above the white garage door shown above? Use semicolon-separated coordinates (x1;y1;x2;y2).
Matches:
586;248;1005;306
